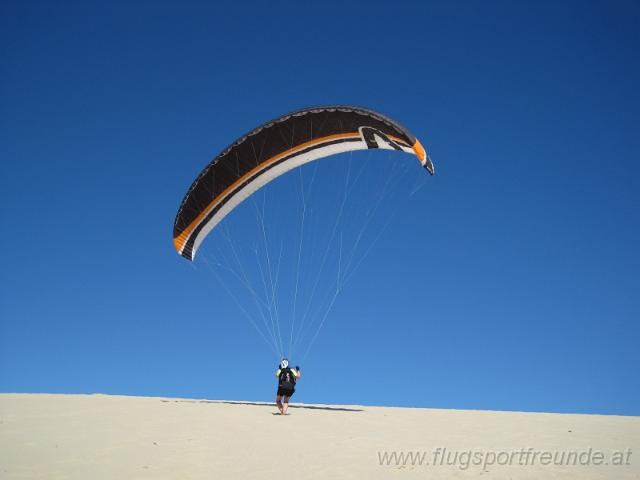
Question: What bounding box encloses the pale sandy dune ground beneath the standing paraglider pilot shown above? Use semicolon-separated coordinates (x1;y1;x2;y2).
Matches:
0;394;640;480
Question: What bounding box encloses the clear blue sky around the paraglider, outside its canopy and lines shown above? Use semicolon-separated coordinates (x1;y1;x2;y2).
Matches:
0;1;640;415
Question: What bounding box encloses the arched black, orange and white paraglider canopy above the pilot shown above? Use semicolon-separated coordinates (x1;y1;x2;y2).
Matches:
173;106;434;260
